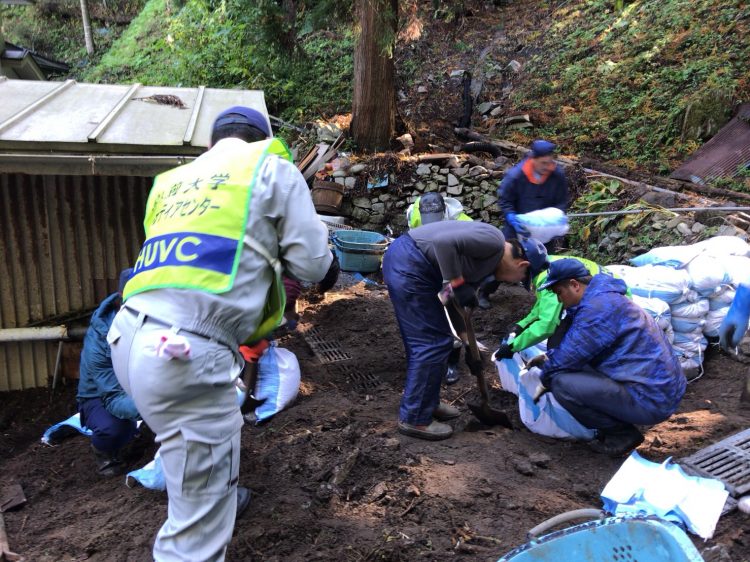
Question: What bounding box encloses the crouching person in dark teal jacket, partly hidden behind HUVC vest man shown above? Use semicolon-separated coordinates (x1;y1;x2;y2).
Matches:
78;269;139;476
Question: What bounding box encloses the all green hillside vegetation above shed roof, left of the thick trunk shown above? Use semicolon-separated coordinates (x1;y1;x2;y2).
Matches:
3;0;354;120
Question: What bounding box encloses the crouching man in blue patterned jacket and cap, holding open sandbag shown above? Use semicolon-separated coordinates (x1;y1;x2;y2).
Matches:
537;259;686;456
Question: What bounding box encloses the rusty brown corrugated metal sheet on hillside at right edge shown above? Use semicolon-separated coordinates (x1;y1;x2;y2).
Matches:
671;104;750;184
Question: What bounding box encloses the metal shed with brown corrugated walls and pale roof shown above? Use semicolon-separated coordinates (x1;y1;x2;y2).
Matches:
0;77;268;391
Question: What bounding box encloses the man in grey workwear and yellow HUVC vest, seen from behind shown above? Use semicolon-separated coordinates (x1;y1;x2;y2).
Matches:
107;106;332;562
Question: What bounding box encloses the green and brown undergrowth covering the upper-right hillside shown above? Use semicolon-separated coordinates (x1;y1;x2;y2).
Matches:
513;0;750;172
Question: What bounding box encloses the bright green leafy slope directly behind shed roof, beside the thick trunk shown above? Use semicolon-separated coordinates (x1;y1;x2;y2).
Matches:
83;0;354;119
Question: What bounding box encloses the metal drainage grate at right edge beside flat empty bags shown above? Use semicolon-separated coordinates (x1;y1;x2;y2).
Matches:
680;429;750;492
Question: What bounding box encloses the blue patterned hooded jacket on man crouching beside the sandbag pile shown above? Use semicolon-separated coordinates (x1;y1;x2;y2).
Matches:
542;274;687;417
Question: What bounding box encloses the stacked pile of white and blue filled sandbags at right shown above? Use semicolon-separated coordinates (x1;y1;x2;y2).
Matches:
607;236;750;378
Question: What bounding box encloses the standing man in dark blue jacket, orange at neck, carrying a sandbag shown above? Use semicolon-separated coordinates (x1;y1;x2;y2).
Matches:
497;140;568;245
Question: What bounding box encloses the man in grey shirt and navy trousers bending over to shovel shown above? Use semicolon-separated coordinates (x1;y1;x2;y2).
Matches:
383;221;547;441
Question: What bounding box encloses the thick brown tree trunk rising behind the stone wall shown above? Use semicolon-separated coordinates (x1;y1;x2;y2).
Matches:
351;0;398;151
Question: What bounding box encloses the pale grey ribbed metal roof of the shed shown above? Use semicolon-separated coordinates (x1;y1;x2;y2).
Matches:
0;78;270;156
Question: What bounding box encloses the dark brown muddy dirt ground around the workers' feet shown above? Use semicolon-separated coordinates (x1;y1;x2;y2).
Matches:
0;283;750;562
